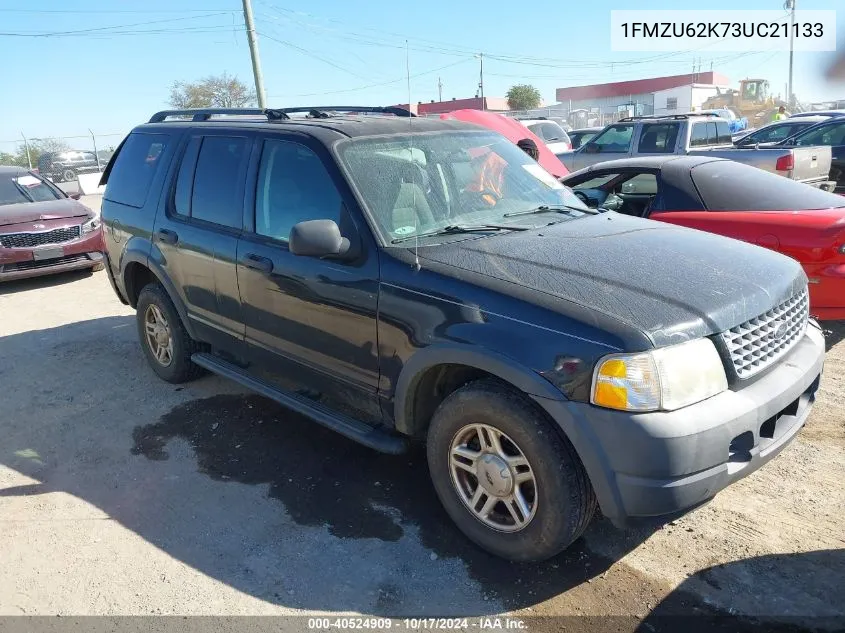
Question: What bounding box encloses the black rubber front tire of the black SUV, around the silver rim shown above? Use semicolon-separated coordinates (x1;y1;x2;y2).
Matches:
427;380;596;561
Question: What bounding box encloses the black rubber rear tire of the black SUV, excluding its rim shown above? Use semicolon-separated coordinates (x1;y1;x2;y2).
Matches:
135;283;204;384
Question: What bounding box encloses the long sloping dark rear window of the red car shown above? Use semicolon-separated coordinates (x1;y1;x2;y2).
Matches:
691;160;845;211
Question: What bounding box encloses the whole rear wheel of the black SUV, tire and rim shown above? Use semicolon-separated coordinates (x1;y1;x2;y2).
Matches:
136;283;202;383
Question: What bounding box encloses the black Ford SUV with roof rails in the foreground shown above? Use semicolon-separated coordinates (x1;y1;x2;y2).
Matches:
102;108;824;560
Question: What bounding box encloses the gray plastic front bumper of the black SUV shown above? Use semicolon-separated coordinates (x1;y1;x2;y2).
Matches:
538;322;825;525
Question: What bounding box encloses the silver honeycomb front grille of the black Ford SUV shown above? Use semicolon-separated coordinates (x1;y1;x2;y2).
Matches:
720;287;810;378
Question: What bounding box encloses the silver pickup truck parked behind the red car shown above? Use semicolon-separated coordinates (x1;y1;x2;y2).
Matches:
557;114;836;191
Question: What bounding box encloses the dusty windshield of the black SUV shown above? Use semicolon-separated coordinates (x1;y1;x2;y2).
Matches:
339;131;591;243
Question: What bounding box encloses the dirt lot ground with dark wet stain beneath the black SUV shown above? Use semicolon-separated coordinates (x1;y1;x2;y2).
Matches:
0;196;845;631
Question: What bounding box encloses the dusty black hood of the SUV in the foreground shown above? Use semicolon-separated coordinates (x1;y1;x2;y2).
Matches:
419;212;807;347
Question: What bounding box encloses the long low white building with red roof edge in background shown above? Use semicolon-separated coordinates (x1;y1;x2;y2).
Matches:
556;71;730;120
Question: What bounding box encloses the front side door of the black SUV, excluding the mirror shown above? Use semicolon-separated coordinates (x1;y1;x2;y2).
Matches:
238;137;381;421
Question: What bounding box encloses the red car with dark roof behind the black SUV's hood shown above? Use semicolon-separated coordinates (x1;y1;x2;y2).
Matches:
562;156;845;320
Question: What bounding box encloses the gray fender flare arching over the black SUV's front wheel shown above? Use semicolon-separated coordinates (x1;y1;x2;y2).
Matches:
393;343;566;435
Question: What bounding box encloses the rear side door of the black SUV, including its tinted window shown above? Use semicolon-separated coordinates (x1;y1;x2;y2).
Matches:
150;130;253;357
